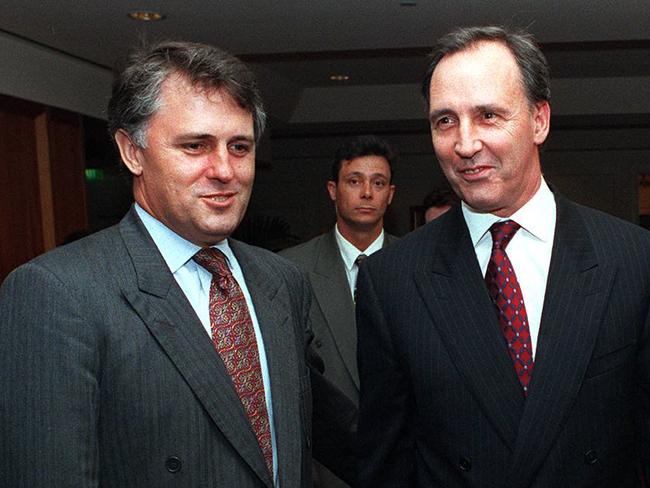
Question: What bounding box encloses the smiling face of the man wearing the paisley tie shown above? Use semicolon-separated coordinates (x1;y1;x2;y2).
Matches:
116;74;255;247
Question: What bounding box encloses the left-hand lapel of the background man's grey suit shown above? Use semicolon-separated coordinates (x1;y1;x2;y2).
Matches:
312;229;359;389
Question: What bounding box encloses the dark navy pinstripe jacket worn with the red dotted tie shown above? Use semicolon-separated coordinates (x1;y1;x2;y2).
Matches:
357;195;650;488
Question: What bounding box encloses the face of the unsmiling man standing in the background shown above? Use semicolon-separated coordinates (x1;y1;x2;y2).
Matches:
327;156;395;231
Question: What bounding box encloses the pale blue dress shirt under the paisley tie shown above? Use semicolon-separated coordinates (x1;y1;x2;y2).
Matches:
135;203;279;487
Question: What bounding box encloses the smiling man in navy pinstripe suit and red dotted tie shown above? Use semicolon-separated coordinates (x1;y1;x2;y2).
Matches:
357;27;650;488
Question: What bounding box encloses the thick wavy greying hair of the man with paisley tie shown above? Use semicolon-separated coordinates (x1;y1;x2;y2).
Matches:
108;41;266;148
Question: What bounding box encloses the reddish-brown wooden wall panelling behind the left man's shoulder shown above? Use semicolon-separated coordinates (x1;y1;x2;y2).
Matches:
0;95;88;281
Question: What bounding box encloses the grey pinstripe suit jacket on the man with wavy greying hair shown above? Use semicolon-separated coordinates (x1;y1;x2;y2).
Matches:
0;210;311;488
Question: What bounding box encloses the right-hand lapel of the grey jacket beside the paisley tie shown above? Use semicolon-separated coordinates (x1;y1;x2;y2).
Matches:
230;239;302;486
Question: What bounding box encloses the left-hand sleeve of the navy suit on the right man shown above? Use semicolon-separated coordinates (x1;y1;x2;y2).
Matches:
356;262;415;488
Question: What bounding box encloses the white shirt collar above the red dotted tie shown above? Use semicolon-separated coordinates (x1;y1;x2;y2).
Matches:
462;177;556;247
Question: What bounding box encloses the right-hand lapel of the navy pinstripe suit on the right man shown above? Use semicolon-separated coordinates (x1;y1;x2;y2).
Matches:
509;195;614;487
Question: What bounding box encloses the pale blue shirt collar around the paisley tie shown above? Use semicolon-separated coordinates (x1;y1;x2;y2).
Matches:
135;203;236;274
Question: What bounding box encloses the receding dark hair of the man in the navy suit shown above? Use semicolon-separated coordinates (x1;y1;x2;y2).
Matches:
422;26;551;106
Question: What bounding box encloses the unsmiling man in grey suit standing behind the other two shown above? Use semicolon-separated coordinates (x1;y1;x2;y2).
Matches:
281;136;397;488
